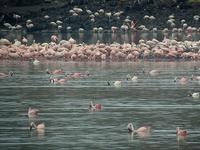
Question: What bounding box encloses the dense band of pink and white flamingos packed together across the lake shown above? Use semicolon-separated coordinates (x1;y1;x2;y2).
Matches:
0;32;200;61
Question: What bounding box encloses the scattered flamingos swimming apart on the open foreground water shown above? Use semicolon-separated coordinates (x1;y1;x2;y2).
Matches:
0;65;200;139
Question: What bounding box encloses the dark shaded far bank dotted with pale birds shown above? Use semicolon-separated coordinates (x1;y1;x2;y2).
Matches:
0;0;200;32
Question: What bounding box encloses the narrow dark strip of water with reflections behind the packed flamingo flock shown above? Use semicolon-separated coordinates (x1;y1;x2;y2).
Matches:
0;31;200;44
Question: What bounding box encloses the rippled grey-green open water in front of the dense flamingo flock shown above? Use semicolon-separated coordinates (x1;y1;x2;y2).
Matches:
0;61;200;150
